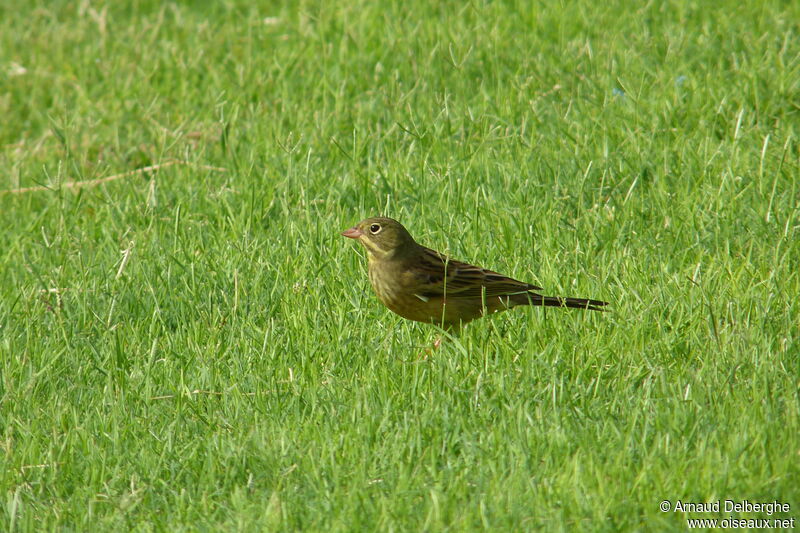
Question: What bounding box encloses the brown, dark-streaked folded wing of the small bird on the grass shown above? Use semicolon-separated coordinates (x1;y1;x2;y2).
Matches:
413;248;541;298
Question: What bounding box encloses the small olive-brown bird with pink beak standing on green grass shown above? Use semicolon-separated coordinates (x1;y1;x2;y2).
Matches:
342;216;608;332
